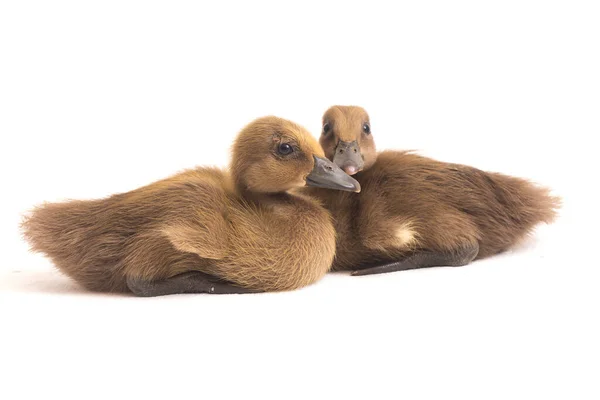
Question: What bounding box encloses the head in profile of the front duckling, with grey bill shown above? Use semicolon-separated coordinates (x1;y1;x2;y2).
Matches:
230;116;360;193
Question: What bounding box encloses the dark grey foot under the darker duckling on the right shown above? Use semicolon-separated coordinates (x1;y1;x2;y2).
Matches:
352;243;479;276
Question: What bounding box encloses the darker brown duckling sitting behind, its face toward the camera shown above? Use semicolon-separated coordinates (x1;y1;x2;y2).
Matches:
302;106;561;275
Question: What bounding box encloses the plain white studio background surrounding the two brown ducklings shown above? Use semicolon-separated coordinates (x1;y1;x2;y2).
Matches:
0;0;600;399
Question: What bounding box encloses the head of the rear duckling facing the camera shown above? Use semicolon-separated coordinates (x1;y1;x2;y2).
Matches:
319;106;377;175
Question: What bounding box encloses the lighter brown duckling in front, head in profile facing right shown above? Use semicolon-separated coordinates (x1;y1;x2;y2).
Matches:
22;116;360;296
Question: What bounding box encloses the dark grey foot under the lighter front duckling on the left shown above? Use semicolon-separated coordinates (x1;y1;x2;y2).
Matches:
127;271;255;297
